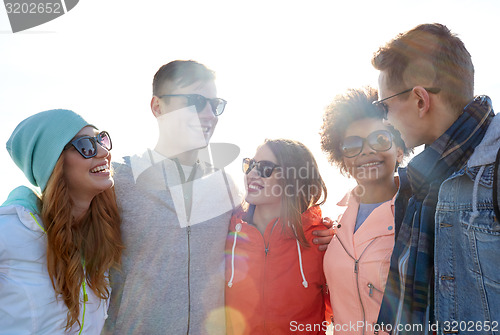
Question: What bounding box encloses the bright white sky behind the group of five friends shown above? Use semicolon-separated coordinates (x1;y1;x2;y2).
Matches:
0;0;500;214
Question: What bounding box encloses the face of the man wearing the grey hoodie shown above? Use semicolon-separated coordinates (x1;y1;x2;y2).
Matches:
151;81;218;155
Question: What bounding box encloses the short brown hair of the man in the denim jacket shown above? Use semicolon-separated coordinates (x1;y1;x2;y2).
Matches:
372;23;474;113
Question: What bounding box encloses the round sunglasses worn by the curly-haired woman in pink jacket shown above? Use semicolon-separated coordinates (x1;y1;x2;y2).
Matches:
341;130;392;158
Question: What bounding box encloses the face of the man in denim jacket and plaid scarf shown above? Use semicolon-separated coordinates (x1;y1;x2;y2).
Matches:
378;71;425;148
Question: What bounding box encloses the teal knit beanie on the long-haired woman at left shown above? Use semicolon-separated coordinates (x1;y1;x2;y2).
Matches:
7;109;89;192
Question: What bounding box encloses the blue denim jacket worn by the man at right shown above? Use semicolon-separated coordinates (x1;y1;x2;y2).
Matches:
431;115;500;334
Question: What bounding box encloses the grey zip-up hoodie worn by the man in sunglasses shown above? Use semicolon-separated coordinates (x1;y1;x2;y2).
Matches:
103;151;240;335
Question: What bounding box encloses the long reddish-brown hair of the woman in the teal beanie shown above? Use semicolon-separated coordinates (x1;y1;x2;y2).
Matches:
40;155;123;331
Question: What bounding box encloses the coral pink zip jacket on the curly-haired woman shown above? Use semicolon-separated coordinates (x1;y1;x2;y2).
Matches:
323;188;394;335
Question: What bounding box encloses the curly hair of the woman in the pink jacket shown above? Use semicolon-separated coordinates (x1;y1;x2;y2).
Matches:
320;86;410;175
